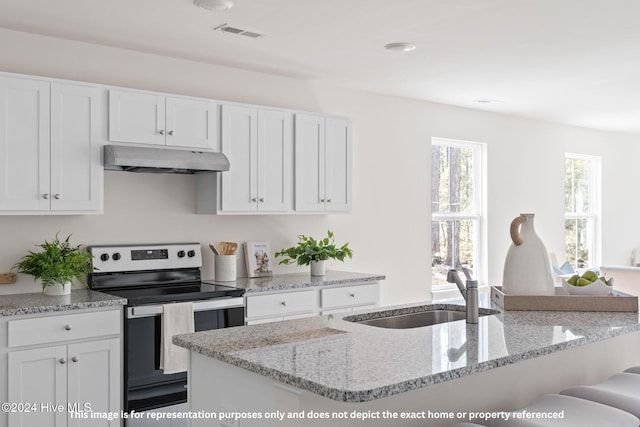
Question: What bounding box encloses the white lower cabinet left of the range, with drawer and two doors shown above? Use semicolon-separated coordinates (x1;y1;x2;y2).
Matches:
7;310;122;427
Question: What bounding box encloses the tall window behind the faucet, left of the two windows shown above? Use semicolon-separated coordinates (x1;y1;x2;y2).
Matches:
431;138;485;287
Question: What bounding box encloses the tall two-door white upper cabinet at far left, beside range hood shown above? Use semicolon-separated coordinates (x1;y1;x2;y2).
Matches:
0;78;102;214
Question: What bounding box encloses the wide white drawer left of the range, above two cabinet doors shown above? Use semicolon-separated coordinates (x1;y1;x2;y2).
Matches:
8;310;121;347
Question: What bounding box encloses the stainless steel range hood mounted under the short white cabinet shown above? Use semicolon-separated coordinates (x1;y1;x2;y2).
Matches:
104;145;229;174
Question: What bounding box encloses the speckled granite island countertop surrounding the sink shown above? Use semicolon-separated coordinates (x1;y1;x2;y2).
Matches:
173;303;640;402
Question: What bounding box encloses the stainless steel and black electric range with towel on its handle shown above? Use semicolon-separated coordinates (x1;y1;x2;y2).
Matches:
88;243;244;418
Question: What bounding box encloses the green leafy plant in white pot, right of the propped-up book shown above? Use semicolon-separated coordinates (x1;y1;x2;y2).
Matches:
275;230;353;276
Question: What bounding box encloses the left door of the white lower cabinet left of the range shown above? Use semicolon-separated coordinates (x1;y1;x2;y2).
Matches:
7;346;67;427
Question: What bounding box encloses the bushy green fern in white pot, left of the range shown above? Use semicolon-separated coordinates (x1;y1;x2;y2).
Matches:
13;234;93;296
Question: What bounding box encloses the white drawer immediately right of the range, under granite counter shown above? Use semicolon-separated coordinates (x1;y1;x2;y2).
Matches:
247;291;318;318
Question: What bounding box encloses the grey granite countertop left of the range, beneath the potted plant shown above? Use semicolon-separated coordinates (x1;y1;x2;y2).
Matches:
0;289;127;316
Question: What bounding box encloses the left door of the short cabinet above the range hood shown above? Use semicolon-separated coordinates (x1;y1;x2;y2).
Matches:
109;90;166;145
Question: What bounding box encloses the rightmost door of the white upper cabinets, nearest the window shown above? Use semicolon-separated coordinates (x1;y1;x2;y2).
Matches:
325;117;351;212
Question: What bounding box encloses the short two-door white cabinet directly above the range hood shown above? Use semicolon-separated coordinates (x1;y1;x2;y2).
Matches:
109;90;218;150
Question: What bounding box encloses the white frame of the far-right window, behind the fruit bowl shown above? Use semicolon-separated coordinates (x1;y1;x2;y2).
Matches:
563;153;602;270
